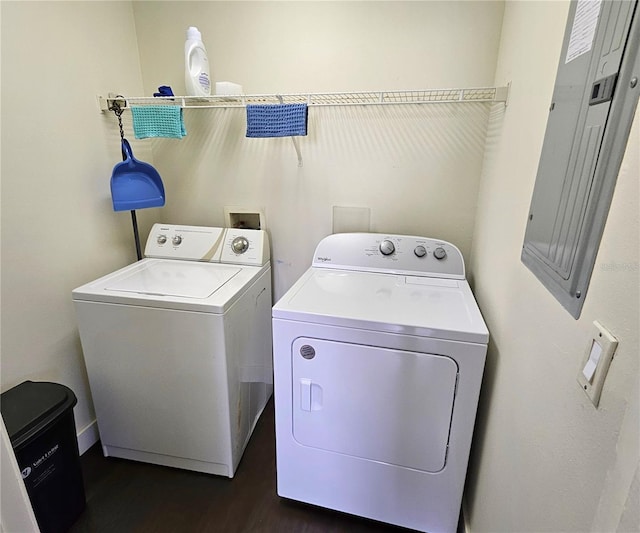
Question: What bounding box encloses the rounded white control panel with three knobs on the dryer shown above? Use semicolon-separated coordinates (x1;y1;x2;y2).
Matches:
313;233;465;279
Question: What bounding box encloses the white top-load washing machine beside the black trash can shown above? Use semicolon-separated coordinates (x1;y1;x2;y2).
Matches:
73;224;273;477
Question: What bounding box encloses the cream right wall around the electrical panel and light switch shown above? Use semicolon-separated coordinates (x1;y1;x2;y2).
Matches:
467;2;640;532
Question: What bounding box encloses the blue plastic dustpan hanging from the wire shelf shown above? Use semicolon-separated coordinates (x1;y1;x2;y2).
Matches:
111;139;164;211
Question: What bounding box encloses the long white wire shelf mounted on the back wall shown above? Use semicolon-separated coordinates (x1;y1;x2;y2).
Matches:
98;87;509;111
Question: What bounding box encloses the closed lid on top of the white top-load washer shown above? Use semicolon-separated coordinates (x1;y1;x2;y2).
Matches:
104;261;240;299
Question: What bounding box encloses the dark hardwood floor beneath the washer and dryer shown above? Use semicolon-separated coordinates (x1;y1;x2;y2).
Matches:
71;399;408;533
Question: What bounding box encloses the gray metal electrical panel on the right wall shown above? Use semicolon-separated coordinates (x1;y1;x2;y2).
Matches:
522;0;640;318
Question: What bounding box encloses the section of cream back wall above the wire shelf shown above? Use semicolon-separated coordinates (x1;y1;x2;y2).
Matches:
134;0;503;94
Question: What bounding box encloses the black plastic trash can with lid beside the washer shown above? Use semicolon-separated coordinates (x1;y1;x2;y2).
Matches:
0;381;85;533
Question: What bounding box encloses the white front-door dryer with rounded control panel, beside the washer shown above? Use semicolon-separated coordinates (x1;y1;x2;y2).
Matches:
273;233;489;533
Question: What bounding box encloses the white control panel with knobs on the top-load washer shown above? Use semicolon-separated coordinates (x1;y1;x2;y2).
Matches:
144;224;269;266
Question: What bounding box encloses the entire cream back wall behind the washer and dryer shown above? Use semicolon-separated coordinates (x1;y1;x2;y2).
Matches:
134;2;503;299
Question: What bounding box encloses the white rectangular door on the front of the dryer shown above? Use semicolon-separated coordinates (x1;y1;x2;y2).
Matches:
291;337;458;472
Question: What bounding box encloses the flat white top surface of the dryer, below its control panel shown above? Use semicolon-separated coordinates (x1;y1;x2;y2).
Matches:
273;267;489;344
